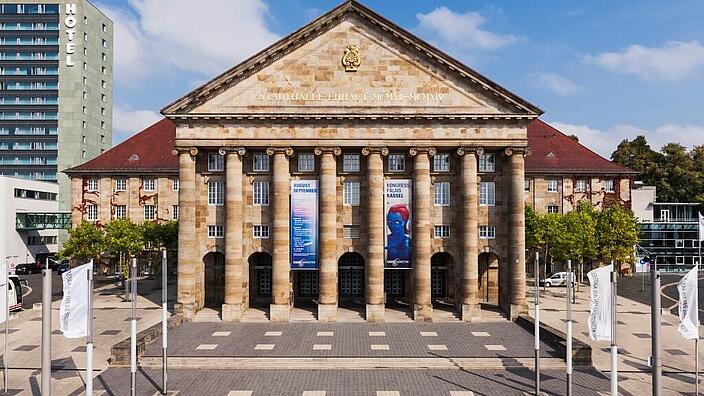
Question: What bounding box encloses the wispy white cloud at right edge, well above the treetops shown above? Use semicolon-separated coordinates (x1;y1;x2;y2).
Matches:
585;41;704;81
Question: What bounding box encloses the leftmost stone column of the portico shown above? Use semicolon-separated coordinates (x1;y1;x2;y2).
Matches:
172;147;198;319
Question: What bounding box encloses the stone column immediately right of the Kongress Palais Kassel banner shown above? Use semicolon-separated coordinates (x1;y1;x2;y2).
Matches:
410;147;435;321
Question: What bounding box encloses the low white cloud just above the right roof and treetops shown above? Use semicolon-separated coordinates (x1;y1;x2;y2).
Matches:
550;122;704;158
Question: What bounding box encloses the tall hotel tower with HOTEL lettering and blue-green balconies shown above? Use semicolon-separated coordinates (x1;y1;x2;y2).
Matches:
0;0;113;217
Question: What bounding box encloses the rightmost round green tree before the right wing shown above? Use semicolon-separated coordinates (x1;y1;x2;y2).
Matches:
596;205;640;264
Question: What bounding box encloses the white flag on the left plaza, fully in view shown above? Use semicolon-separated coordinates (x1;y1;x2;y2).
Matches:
59;260;93;338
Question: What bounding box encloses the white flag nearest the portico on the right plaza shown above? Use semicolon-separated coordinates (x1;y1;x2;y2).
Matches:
587;264;614;341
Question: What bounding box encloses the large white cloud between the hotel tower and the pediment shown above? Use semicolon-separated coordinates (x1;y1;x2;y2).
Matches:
101;0;278;83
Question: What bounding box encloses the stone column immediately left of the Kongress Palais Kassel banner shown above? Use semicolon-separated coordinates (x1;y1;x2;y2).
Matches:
362;147;389;322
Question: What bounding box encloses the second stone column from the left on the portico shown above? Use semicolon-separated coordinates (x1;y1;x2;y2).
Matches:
220;147;245;322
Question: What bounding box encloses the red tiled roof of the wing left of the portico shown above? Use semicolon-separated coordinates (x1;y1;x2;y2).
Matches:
64;119;178;174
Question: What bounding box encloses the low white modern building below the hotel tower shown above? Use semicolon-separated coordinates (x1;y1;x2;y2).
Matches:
0;176;58;268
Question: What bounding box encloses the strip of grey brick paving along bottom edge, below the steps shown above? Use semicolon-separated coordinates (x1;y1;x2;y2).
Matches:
88;368;616;396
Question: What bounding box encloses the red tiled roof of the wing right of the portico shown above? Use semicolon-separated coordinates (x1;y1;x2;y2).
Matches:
526;119;638;174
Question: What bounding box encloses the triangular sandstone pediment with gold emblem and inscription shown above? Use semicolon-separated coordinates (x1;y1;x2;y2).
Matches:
162;1;541;117
